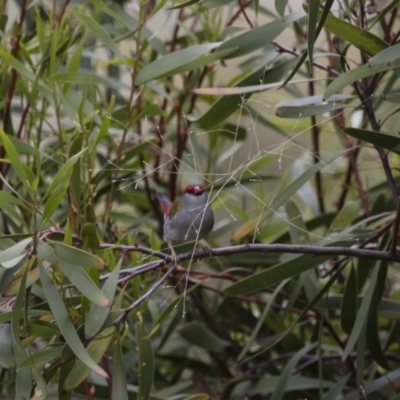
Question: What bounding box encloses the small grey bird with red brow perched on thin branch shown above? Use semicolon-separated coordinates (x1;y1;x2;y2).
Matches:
156;185;214;265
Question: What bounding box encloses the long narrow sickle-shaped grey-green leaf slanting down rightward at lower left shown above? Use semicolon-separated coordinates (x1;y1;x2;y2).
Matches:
38;259;108;378
